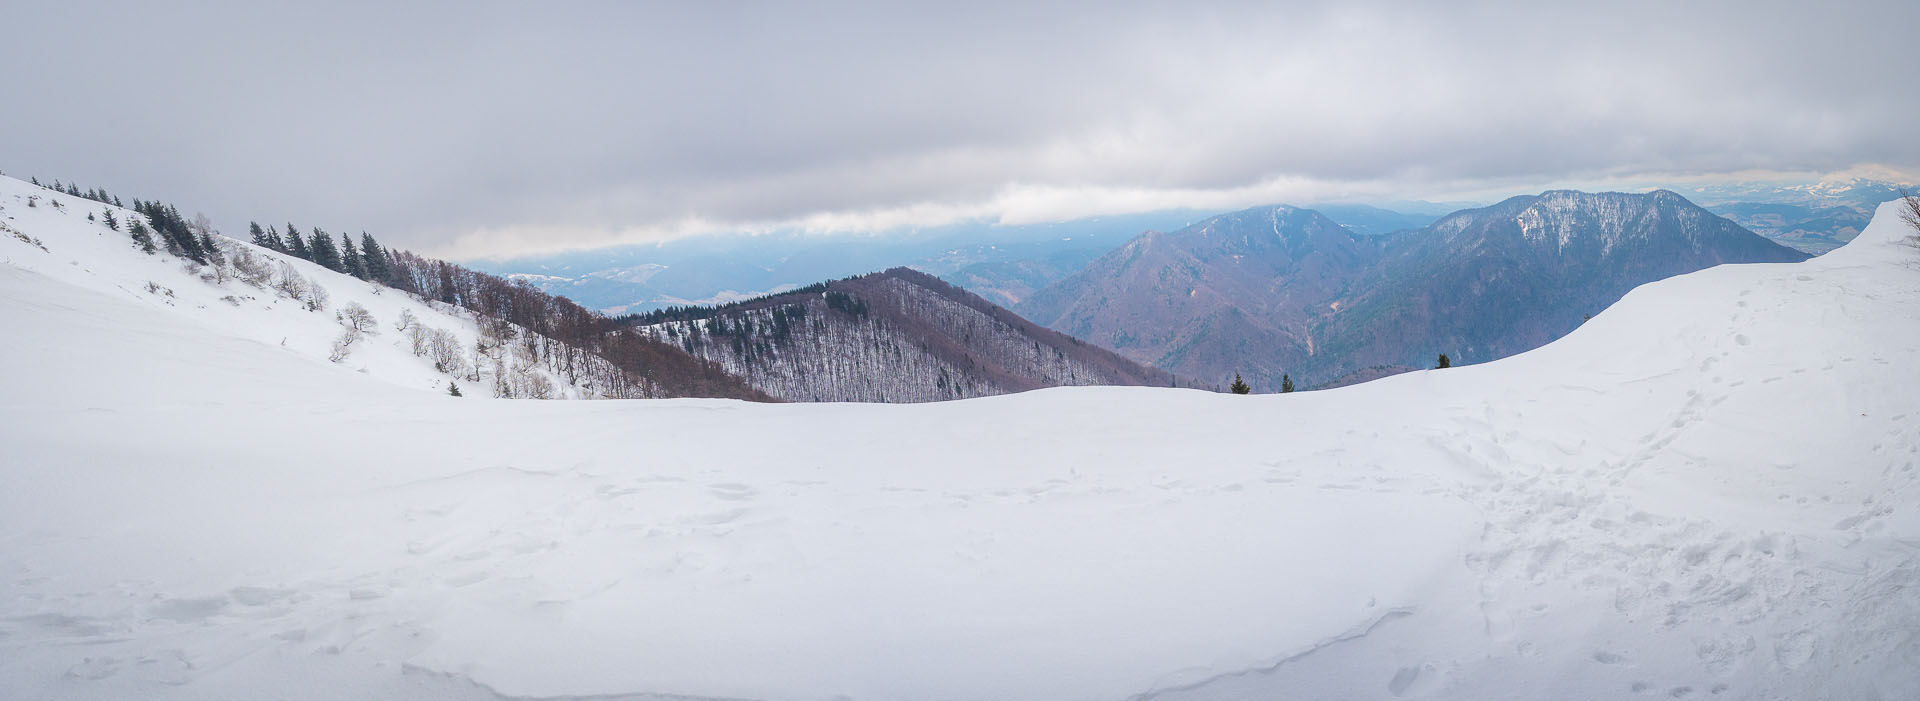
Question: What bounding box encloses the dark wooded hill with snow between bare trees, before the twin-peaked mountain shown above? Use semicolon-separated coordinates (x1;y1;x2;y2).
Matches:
626;267;1175;401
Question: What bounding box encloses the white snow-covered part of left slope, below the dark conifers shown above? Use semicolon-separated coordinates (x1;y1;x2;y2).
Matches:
0;177;637;398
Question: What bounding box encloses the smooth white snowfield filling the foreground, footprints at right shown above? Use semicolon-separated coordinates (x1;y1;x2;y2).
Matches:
0;181;1920;699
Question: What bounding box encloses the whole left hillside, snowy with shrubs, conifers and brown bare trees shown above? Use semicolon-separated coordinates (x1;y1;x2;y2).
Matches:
0;177;766;399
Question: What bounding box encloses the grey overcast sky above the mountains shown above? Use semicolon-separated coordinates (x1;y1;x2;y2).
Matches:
0;0;1920;257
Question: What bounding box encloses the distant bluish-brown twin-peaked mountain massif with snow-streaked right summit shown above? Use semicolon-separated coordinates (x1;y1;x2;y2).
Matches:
1018;190;1807;392
